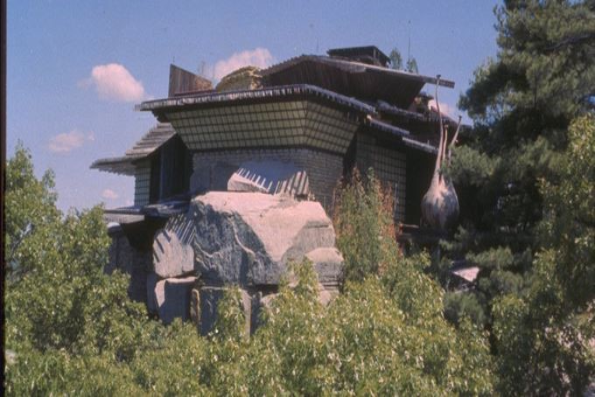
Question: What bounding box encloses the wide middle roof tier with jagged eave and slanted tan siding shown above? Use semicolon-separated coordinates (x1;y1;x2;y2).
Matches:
139;85;435;153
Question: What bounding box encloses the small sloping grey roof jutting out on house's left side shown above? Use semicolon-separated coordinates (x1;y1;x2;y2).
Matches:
91;123;176;175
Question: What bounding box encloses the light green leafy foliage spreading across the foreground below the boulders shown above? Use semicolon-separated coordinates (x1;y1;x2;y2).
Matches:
4;144;495;396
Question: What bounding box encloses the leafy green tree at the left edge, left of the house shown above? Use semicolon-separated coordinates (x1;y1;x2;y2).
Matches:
4;146;159;395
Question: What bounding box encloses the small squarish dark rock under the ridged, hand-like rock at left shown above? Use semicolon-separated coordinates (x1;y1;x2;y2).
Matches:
155;277;196;324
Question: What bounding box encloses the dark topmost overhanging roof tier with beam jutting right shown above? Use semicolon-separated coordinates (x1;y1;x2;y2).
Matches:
261;55;454;108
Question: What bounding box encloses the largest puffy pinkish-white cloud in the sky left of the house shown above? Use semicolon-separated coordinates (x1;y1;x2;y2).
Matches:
79;63;147;102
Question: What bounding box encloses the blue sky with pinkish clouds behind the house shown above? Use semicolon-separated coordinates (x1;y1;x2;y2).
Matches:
7;0;497;210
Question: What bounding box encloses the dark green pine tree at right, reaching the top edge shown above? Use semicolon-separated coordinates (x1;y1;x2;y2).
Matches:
449;0;595;232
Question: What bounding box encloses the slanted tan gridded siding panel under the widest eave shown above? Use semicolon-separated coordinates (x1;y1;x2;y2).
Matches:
168;101;357;154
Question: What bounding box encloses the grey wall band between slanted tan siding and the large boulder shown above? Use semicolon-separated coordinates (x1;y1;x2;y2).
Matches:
190;148;343;215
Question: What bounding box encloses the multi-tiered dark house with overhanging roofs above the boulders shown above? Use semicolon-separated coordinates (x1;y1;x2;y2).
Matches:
91;46;454;324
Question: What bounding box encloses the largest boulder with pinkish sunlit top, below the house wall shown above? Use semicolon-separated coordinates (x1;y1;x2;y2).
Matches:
187;192;341;286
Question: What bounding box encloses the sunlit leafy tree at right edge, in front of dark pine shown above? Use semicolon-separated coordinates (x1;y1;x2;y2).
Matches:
494;116;595;395
